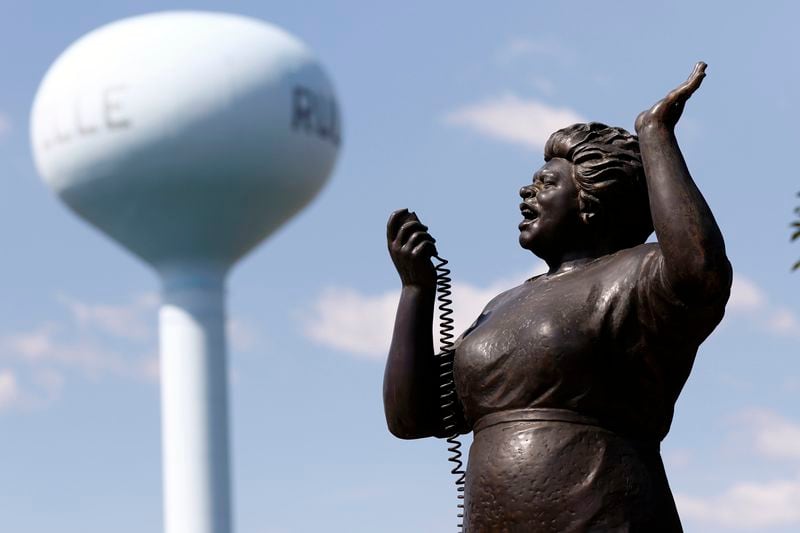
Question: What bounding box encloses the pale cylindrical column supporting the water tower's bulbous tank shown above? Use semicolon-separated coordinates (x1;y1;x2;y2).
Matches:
159;277;231;533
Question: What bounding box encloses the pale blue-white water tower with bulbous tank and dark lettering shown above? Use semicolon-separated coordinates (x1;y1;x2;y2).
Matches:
31;12;341;533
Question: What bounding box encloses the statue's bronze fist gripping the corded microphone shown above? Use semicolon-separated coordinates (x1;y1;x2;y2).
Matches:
386;209;436;289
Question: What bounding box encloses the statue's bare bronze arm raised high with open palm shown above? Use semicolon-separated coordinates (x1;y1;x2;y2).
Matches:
636;62;732;303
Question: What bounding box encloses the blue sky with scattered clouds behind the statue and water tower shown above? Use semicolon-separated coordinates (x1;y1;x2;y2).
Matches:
0;0;800;533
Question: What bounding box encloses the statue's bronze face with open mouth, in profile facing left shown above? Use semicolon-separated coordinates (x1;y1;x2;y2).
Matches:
519;158;585;260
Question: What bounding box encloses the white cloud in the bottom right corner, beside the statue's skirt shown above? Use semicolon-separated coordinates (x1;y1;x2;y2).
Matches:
675;480;800;531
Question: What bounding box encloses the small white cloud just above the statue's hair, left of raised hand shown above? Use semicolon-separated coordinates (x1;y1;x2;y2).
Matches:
444;93;585;149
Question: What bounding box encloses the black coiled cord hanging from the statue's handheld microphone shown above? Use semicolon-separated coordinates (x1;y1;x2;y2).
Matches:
433;255;466;531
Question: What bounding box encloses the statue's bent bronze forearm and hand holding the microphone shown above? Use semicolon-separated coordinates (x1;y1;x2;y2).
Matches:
383;209;441;439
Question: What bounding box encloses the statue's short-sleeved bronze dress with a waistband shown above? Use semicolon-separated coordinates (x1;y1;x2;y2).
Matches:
455;244;728;533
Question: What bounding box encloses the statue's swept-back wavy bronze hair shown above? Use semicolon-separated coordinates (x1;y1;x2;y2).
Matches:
544;122;653;249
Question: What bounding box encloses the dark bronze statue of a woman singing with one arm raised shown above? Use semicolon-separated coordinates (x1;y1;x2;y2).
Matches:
384;63;732;533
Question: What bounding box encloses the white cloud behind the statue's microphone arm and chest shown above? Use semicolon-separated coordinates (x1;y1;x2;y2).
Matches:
303;263;545;358
